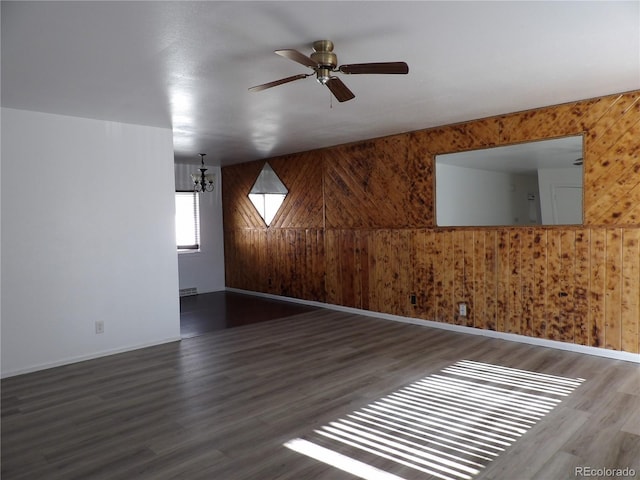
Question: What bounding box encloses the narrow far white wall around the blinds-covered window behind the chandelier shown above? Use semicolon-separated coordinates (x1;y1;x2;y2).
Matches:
175;165;225;293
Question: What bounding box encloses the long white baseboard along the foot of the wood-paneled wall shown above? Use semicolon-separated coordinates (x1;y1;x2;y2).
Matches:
226;287;640;363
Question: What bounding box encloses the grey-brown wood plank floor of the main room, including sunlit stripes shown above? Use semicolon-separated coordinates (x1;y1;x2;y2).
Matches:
1;297;640;480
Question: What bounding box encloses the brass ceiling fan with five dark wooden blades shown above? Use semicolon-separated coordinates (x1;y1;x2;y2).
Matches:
249;40;409;102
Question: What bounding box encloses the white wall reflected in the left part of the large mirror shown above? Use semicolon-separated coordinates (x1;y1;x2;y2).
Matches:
436;164;540;226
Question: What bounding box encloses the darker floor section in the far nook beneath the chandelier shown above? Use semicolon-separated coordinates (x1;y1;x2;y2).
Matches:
180;291;315;338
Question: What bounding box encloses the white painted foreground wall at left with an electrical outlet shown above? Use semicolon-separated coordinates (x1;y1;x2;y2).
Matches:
1;108;180;376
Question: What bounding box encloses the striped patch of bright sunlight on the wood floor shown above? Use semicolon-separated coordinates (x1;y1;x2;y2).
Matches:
285;360;584;480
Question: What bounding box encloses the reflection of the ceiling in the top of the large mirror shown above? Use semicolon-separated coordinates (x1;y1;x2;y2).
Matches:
437;135;582;174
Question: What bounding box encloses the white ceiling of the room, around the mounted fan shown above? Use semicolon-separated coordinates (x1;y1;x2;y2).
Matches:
1;1;640;165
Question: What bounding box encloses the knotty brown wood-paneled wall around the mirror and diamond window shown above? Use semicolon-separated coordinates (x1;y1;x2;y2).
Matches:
222;91;640;353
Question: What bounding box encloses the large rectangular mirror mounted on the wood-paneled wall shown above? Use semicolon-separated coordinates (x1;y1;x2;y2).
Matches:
435;135;583;227
